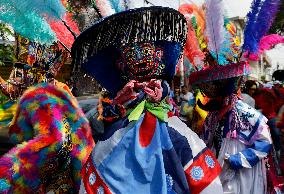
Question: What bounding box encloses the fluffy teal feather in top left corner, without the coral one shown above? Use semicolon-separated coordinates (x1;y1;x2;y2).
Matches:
0;0;56;45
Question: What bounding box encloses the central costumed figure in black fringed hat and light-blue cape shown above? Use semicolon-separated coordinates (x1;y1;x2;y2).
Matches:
72;4;223;194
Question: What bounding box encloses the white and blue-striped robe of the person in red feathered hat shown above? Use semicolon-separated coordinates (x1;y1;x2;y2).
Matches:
205;100;272;194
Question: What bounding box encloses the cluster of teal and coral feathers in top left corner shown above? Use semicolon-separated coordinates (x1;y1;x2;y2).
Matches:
0;0;79;47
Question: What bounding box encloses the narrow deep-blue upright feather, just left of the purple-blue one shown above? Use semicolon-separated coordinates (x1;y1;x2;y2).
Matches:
243;0;261;53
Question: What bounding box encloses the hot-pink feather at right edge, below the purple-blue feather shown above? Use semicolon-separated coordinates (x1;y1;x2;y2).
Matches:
245;34;284;61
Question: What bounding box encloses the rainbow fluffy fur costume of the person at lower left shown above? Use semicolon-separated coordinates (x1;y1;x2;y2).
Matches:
0;84;94;193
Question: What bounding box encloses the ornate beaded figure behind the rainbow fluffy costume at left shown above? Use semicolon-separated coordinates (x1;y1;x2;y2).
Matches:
0;40;72;135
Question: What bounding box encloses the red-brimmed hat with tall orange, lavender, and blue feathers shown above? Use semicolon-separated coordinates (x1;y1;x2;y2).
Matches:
179;0;279;97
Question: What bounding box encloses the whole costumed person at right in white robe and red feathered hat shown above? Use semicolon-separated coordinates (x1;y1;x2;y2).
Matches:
179;0;277;194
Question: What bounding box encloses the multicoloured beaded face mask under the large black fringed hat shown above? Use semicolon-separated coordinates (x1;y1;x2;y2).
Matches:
117;43;165;81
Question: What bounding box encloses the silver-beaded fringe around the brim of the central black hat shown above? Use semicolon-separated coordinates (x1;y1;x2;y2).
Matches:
72;7;187;71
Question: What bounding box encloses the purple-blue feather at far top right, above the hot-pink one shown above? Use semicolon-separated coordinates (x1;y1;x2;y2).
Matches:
255;0;281;42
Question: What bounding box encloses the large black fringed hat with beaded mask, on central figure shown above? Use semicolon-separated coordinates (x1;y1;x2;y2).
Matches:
72;7;187;95
